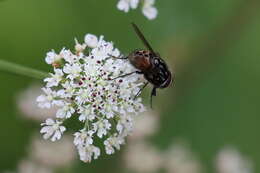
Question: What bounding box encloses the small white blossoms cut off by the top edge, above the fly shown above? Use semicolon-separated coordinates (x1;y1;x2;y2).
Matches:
117;0;158;20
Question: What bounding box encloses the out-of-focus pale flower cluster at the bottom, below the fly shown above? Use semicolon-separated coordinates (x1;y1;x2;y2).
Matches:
123;111;203;173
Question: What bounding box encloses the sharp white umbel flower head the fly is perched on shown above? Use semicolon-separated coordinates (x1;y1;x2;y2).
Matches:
37;34;145;162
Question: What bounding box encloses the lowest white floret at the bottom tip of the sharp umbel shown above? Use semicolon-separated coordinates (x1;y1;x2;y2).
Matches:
78;145;100;162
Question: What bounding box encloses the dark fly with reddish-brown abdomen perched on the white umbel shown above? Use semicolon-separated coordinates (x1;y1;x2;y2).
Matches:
112;23;172;106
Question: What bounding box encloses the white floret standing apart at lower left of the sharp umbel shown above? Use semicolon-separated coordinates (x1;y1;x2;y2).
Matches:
40;118;66;141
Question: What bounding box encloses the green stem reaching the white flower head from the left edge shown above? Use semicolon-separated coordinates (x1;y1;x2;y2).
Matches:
0;60;48;79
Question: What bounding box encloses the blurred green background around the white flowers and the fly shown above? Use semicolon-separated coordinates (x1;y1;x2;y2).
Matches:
0;0;260;173
